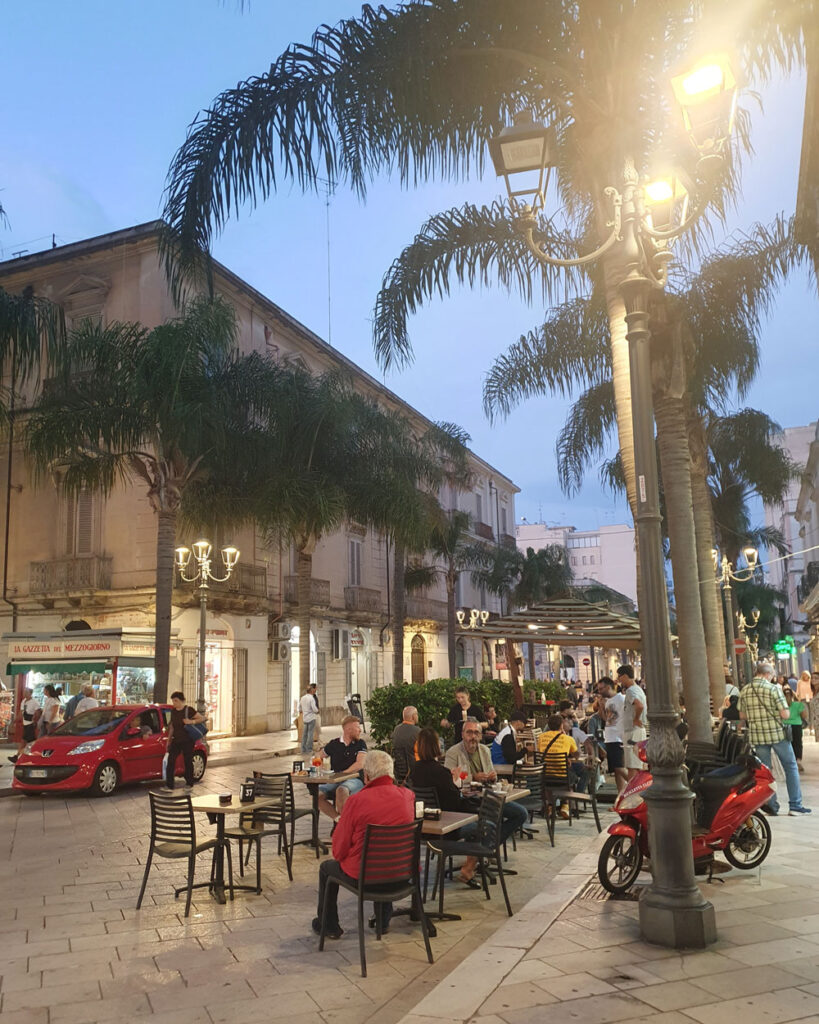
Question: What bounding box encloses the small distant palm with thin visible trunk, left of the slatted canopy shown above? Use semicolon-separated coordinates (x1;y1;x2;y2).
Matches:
404;506;482;679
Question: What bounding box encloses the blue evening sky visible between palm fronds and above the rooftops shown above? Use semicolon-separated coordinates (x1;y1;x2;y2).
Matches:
0;0;817;528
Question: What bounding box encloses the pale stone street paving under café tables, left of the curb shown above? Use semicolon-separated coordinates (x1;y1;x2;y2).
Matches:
0;737;601;1024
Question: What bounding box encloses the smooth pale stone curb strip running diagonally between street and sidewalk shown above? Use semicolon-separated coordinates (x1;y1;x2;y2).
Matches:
398;829;607;1024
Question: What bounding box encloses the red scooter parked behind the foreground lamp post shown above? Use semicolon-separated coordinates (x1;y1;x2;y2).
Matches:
597;741;774;894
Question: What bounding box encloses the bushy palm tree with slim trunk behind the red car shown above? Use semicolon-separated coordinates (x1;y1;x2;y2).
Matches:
26;300;244;700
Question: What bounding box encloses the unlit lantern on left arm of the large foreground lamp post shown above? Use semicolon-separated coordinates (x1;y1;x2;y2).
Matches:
489;111;555;211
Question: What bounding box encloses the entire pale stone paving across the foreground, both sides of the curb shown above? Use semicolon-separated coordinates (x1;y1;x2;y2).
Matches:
0;738;819;1024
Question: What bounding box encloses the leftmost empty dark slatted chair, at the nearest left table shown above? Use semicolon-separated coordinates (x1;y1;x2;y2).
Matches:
136;793;233;918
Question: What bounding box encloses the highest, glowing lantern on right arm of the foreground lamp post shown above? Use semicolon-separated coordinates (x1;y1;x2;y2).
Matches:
672;53;737;160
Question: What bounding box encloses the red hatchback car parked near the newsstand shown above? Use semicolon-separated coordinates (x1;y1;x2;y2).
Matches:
12;705;208;797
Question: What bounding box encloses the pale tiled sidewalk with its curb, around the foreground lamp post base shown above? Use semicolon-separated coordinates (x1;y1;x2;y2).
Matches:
401;738;819;1024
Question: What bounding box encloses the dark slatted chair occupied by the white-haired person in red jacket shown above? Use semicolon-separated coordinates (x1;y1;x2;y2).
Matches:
318;821;433;978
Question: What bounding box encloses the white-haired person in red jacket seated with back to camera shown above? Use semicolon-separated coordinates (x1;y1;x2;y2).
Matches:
312;751;415;939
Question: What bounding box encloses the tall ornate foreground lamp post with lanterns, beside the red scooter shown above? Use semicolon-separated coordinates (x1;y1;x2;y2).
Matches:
489;55;736;948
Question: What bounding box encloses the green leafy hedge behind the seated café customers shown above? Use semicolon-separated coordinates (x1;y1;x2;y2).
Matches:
367;679;515;743
